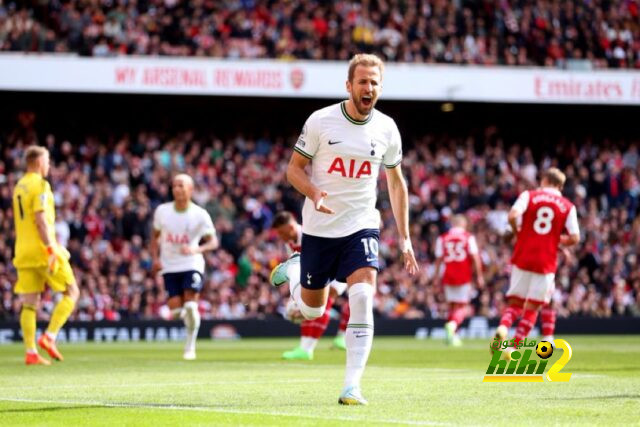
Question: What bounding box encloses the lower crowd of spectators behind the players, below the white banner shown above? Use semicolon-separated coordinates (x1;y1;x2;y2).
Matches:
0;113;640;320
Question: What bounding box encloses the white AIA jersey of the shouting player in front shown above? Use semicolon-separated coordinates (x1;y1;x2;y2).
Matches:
294;102;402;237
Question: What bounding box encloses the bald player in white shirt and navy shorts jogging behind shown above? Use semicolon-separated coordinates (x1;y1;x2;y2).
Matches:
151;174;218;360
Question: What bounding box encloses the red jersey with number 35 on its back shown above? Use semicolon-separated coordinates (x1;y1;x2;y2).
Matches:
436;227;478;286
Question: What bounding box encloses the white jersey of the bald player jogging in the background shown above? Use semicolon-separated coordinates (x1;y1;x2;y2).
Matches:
153;202;216;274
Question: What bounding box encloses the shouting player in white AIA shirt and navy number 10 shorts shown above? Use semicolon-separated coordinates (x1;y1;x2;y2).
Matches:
287;54;418;405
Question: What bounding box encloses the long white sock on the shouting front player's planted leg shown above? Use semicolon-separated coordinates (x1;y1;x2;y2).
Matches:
344;283;374;388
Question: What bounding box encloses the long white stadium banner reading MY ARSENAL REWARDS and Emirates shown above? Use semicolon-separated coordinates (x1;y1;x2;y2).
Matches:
0;54;640;105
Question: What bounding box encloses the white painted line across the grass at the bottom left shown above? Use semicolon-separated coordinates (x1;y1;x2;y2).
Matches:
0;397;449;426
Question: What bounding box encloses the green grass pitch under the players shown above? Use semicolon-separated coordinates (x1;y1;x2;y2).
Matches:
0;336;640;426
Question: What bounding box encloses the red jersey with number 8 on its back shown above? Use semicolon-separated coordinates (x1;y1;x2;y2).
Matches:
511;189;578;274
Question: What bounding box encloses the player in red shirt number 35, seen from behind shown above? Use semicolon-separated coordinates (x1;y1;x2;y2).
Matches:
434;215;484;347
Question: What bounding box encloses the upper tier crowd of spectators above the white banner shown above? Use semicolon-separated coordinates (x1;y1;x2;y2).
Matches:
0;0;640;68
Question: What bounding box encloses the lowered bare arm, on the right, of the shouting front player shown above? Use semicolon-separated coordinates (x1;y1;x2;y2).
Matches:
386;164;419;275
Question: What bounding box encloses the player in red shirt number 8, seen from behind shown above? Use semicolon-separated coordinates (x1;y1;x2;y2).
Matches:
496;168;580;352
